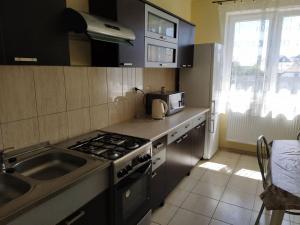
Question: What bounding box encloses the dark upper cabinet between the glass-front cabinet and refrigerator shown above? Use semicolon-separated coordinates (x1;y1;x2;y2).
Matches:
177;20;195;68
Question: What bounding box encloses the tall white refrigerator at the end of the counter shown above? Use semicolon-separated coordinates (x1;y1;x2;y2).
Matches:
179;43;223;159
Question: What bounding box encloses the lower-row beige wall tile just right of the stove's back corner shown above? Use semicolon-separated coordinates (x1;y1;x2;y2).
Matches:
108;97;125;125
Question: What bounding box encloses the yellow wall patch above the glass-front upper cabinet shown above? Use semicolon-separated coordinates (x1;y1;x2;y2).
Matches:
150;0;192;21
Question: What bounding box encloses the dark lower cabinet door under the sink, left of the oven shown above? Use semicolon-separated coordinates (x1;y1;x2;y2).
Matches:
57;191;109;225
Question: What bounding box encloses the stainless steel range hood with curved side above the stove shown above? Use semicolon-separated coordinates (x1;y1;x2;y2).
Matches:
64;8;135;45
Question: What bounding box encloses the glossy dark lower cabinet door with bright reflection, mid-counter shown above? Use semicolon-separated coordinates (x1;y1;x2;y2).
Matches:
166;131;193;193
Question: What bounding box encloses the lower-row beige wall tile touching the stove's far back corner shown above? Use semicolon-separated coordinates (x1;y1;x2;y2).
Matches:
90;104;108;130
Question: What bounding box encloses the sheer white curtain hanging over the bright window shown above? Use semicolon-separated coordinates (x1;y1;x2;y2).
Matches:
219;0;300;144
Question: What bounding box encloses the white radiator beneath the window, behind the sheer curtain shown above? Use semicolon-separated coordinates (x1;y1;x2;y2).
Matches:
226;112;300;145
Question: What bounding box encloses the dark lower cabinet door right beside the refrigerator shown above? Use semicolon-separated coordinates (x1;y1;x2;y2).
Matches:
191;121;206;166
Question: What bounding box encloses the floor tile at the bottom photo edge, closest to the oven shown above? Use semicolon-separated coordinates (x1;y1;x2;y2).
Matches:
152;204;178;225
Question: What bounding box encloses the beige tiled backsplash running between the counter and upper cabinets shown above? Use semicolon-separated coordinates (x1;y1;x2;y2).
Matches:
0;66;175;148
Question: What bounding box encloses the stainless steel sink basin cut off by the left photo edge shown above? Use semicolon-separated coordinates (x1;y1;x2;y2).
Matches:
0;174;31;207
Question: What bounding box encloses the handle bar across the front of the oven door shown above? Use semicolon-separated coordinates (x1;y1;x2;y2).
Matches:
117;161;152;188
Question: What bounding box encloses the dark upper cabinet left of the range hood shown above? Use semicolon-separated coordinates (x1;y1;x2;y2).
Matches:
0;0;70;65
